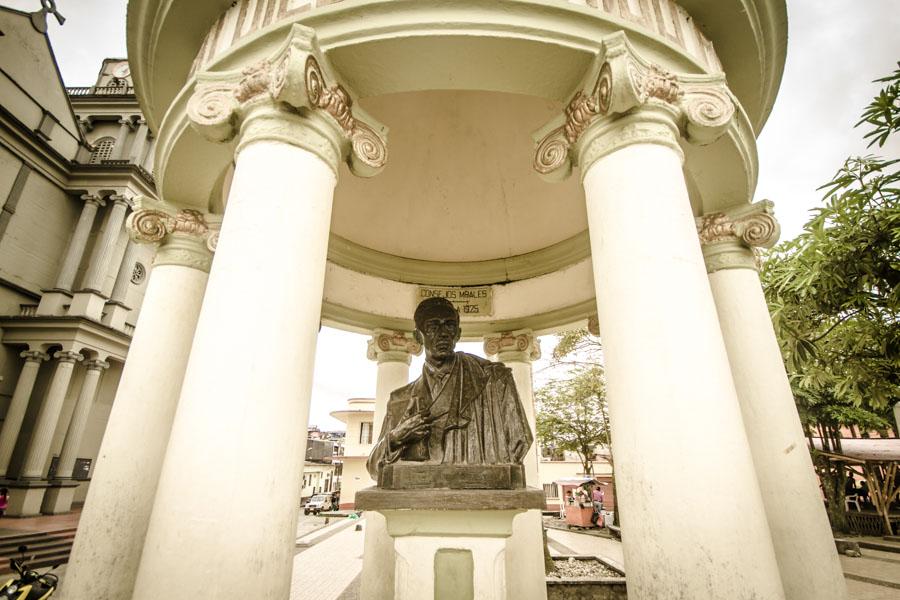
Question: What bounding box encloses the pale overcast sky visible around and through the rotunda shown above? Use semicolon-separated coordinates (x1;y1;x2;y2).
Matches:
7;0;900;429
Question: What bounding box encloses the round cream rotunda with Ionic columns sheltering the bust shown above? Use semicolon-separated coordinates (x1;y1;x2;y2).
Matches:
62;0;846;600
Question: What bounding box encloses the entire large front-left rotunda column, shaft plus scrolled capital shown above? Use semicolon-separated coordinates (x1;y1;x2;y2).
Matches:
133;36;387;600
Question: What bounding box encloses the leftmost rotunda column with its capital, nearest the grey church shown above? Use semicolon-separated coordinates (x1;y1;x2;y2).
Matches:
60;204;218;600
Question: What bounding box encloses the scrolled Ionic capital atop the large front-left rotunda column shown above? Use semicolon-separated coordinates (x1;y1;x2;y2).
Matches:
187;25;387;177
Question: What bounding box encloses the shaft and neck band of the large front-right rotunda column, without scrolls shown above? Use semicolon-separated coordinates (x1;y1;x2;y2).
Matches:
580;108;784;600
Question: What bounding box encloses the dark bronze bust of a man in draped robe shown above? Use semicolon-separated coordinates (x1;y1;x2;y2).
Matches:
367;298;533;489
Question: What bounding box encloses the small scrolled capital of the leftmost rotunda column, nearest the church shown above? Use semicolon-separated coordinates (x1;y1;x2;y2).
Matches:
126;197;222;273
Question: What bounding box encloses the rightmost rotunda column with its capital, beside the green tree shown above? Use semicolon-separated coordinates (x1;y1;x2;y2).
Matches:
700;213;847;600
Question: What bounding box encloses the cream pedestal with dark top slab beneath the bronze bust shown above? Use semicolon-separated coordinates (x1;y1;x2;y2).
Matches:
356;488;544;600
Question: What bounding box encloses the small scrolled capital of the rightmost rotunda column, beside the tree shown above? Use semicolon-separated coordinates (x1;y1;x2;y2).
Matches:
697;200;781;273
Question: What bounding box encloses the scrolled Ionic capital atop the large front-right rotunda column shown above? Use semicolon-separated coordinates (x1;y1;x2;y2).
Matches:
533;33;736;180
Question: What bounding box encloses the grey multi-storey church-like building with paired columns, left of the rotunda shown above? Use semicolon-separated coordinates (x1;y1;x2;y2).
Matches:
0;7;155;515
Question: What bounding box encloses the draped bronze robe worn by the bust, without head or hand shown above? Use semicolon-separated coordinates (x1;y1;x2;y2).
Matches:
367;352;533;481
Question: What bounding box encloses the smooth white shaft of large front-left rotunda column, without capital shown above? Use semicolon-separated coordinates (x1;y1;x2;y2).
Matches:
134;141;336;600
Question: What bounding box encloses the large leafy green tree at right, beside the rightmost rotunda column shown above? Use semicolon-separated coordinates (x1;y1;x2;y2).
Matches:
761;64;900;529
